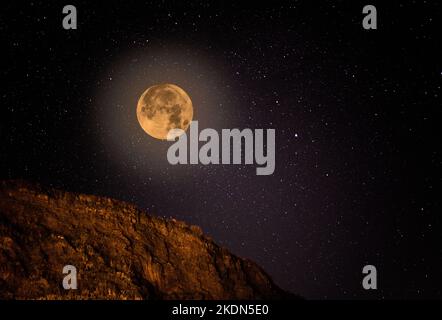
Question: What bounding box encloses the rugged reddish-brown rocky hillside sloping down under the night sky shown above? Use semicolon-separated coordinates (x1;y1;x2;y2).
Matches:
0;181;295;299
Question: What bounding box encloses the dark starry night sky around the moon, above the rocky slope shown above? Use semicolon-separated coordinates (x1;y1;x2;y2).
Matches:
0;1;442;299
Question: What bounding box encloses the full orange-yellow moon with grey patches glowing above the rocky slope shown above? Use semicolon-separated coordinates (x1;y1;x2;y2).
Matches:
137;83;193;140
